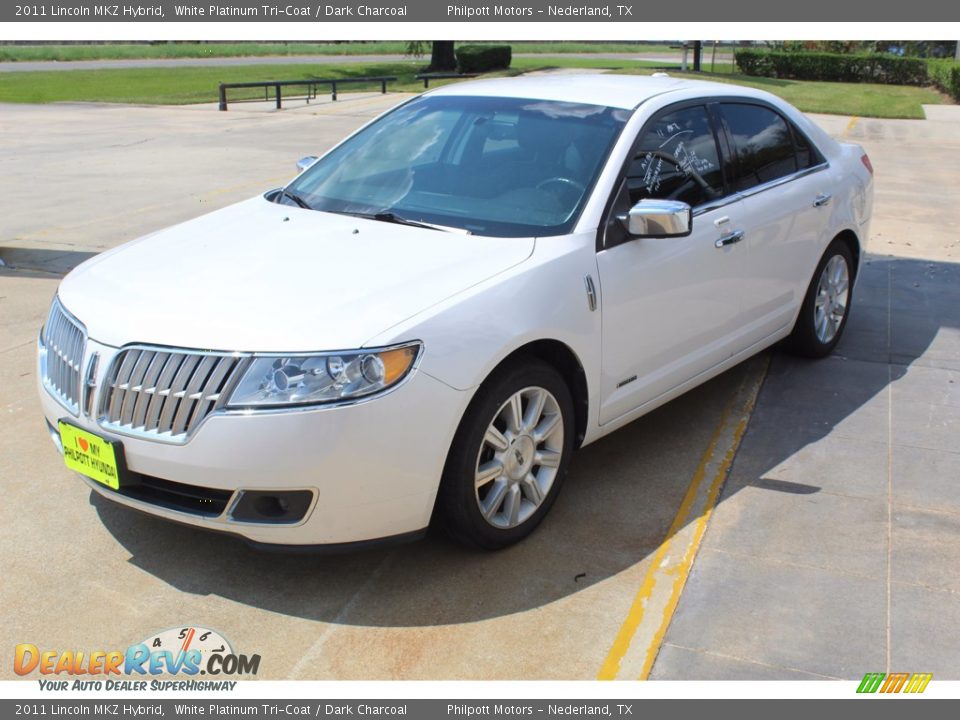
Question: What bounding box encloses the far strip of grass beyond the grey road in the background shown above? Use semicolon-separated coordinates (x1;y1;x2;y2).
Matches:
0;41;677;62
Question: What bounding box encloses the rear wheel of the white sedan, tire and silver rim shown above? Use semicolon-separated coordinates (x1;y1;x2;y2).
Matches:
787;238;854;358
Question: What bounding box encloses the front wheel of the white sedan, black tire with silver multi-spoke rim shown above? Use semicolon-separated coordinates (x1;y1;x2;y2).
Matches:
436;358;575;550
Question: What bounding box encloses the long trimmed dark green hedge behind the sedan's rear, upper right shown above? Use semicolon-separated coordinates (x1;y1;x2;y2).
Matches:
734;50;929;85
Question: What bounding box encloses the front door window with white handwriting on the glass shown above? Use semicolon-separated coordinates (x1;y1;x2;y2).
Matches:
627;106;723;207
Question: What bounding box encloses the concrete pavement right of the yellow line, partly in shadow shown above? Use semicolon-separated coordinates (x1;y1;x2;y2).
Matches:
650;106;960;680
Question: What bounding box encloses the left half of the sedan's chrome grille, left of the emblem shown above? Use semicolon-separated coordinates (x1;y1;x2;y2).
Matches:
40;299;86;415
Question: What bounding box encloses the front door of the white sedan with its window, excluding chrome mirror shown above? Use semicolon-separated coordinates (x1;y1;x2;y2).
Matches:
597;104;745;425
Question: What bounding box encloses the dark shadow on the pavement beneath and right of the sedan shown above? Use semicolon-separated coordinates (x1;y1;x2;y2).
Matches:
91;256;960;627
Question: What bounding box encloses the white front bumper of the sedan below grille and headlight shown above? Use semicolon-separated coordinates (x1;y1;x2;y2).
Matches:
39;341;469;546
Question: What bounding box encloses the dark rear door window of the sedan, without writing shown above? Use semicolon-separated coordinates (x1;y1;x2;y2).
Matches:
721;103;809;190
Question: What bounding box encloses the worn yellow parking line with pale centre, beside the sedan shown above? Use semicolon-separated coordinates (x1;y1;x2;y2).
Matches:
597;356;769;680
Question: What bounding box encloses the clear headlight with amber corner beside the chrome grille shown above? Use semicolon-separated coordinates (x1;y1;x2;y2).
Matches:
227;343;421;408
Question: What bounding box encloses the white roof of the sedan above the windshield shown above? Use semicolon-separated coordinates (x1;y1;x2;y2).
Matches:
430;73;746;110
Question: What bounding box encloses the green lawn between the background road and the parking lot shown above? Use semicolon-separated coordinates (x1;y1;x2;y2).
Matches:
0;56;944;118
